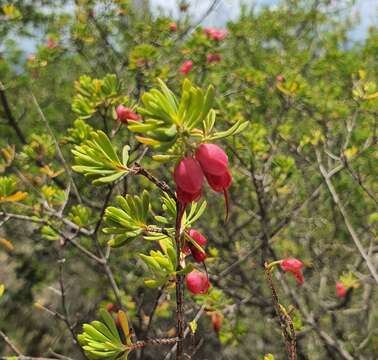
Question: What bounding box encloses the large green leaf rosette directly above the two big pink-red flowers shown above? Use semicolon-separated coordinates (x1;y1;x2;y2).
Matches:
128;79;248;155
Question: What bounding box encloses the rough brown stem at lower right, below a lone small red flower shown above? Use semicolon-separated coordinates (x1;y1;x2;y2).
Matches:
265;263;297;360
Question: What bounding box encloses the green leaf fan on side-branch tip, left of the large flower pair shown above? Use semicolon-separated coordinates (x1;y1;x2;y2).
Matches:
72;131;130;185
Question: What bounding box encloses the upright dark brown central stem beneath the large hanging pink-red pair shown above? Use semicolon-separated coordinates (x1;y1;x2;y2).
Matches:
175;201;185;360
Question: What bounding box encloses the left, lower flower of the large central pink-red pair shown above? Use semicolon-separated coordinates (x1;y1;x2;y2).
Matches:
173;157;204;206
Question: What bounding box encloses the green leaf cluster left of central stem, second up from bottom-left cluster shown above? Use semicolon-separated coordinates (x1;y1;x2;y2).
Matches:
103;190;150;247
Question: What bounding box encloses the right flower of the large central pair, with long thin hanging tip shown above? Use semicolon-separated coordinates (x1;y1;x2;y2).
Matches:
196;144;232;220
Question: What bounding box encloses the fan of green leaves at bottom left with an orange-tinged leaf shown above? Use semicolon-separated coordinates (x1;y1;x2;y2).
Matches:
77;309;131;360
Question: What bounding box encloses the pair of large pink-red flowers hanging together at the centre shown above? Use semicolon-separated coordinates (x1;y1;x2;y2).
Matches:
173;144;232;211
